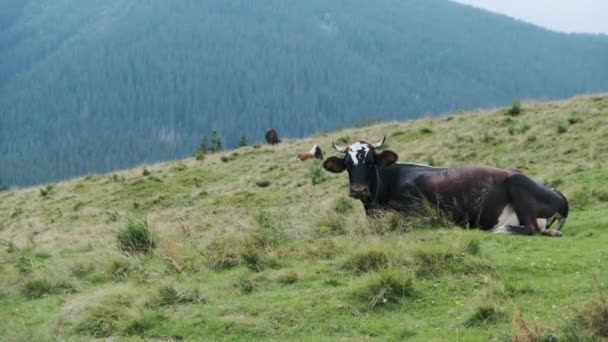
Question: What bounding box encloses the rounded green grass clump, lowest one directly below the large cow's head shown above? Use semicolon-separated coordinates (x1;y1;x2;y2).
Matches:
355;271;415;310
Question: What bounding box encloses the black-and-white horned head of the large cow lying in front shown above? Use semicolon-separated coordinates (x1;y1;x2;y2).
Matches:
323;135;398;201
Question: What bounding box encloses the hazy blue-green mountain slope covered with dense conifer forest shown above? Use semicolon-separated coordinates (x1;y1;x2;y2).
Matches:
0;0;608;185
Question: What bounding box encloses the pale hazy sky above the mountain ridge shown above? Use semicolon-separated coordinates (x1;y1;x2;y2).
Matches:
453;0;608;34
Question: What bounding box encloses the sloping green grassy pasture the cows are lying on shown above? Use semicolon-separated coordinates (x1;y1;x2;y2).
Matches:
0;96;608;341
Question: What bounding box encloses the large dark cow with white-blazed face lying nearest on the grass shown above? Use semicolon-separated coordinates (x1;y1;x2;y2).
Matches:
323;135;568;236
